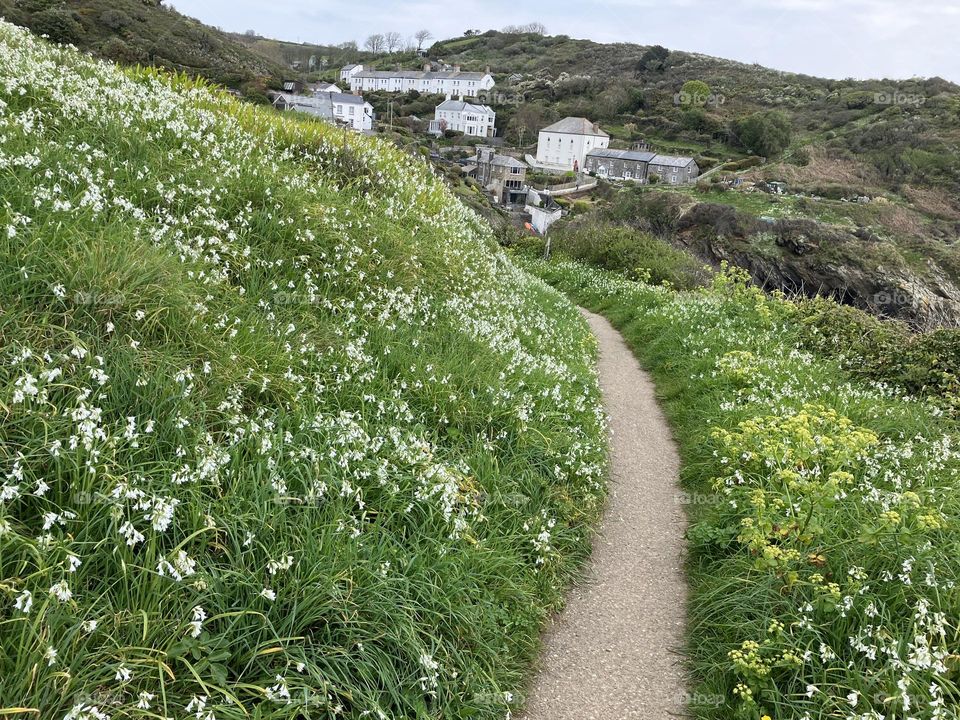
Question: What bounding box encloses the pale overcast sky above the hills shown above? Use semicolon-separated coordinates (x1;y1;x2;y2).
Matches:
168;0;960;82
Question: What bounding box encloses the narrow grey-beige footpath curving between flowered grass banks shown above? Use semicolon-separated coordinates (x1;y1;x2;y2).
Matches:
523;312;686;720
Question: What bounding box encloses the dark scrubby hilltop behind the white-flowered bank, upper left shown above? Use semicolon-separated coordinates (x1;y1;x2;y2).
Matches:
0;0;285;96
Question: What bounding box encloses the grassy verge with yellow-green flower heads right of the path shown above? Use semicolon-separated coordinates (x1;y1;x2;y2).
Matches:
525;259;960;720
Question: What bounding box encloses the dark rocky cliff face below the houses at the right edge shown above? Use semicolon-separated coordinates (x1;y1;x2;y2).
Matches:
676;203;960;329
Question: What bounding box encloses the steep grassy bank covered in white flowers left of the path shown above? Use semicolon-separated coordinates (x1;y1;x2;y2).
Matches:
0;23;605;720
